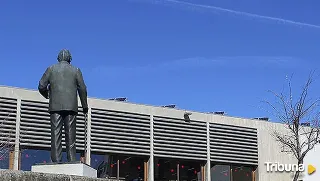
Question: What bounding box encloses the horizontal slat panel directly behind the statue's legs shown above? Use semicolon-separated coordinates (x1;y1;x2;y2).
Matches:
20;100;84;150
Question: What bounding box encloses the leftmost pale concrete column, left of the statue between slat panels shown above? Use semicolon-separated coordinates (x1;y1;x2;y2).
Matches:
13;98;21;170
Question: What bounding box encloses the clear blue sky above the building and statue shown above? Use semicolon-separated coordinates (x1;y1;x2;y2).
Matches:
0;0;320;121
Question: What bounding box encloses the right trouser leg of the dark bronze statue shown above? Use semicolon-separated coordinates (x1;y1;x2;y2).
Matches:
64;112;77;162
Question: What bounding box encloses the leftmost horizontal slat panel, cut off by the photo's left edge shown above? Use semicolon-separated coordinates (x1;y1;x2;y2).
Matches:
0;97;17;147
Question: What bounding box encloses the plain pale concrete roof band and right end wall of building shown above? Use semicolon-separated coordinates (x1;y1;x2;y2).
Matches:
0;86;296;181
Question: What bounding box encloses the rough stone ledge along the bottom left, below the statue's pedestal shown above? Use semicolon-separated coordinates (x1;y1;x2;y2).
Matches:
0;169;115;181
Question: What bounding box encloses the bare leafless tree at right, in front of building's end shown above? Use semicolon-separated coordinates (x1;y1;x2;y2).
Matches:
266;73;320;181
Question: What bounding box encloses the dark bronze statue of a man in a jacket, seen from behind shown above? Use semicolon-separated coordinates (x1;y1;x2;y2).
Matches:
38;49;88;162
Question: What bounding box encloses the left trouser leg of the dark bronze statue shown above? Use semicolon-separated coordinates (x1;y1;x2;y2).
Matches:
50;113;63;162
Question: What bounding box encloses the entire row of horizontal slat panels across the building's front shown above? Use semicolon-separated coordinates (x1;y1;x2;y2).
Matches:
0;88;258;168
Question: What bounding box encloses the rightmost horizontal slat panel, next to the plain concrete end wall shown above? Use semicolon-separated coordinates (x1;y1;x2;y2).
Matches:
210;123;258;165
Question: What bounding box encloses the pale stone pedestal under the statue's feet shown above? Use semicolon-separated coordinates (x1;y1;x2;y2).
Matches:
31;162;97;178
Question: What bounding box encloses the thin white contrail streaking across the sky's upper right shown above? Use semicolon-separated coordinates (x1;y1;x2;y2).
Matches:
151;0;320;29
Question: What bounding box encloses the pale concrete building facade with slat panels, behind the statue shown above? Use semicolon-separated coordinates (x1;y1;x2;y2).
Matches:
0;86;296;181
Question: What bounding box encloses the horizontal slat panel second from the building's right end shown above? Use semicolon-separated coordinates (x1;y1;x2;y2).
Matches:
154;116;207;160
